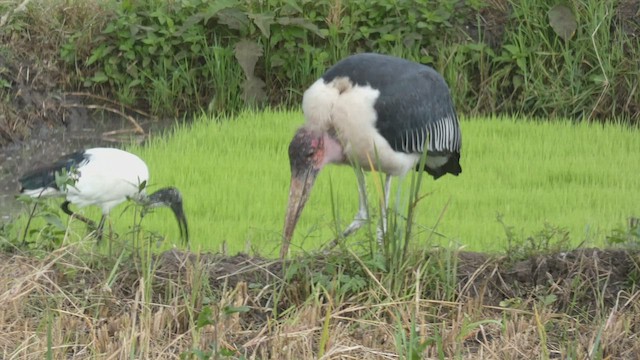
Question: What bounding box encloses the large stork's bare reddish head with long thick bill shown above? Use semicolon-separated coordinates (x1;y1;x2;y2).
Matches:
280;127;344;258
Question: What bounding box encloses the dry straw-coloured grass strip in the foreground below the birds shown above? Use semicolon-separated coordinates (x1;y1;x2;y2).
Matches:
0;246;640;359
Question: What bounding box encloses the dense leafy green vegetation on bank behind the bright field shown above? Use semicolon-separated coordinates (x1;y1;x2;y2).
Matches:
0;0;640;122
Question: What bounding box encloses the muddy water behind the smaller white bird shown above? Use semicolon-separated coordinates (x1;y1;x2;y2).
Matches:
0;116;172;224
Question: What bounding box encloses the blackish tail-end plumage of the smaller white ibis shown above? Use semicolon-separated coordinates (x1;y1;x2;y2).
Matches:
18;151;88;192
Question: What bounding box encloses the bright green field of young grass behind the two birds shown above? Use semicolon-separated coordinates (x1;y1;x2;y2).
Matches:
122;111;640;256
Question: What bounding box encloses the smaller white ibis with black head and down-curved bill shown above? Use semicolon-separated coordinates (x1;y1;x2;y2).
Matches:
19;148;189;244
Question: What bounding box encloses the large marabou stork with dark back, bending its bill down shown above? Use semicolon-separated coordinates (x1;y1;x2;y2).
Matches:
280;53;462;258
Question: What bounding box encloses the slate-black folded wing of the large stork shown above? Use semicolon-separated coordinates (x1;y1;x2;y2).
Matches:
323;54;462;178
